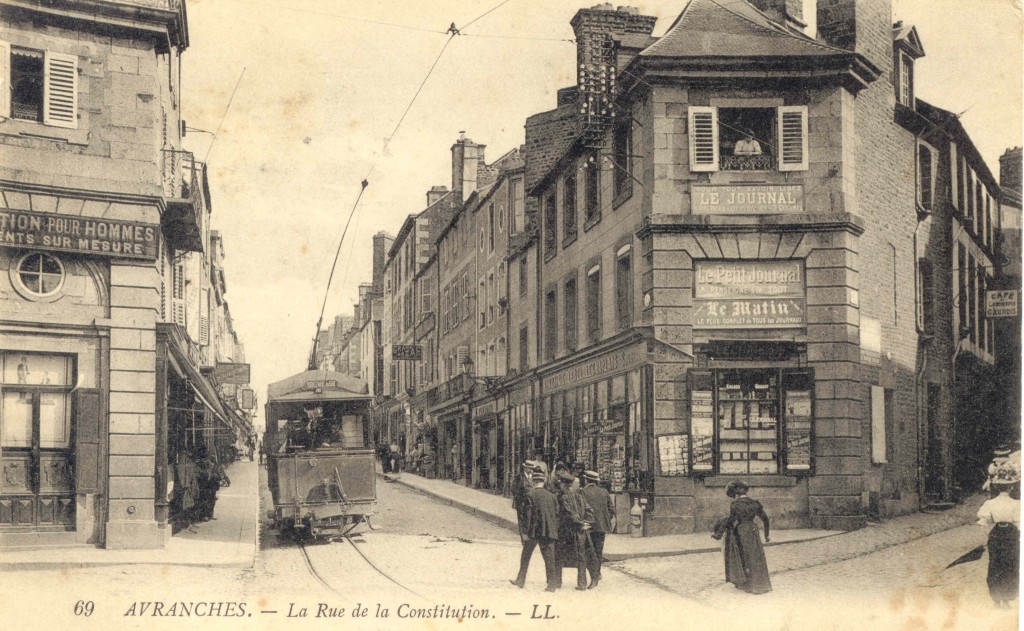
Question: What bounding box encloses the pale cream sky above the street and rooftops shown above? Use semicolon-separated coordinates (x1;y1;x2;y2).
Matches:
182;0;1022;424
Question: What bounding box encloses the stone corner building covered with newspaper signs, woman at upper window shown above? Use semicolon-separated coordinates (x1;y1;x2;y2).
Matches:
527;0;920;535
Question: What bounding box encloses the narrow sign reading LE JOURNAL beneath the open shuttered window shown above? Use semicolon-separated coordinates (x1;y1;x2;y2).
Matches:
690;184;804;215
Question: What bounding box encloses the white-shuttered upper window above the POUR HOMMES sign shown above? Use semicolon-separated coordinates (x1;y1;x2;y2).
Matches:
0;42;78;129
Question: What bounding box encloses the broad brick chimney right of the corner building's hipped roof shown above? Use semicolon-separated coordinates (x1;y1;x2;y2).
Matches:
817;0;893;77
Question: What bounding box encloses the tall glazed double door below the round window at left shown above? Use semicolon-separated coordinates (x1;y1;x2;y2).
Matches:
0;352;75;530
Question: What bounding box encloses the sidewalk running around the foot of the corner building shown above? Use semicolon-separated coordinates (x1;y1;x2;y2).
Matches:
378;467;982;561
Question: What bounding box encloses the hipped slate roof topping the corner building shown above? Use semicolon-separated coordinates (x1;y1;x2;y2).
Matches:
640;0;850;58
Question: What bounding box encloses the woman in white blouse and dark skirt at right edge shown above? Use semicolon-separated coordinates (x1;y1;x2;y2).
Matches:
978;467;1021;607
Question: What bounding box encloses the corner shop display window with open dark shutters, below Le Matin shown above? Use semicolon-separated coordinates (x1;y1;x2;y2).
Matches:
681;369;813;475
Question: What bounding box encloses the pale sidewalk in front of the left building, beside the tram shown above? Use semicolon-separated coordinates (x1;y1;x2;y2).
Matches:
0;460;259;572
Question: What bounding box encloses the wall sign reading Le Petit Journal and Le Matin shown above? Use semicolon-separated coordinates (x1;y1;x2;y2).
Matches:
693;261;807;329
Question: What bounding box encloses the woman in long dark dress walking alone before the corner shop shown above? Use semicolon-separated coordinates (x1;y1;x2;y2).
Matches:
713;480;771;594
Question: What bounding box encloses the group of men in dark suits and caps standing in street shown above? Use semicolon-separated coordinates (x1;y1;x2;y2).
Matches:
511;460;615;592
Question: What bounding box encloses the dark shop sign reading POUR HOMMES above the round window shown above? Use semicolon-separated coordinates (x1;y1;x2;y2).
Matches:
0;209;160;260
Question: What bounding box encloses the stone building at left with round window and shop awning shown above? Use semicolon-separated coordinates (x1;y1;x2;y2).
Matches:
0;0;250;548
